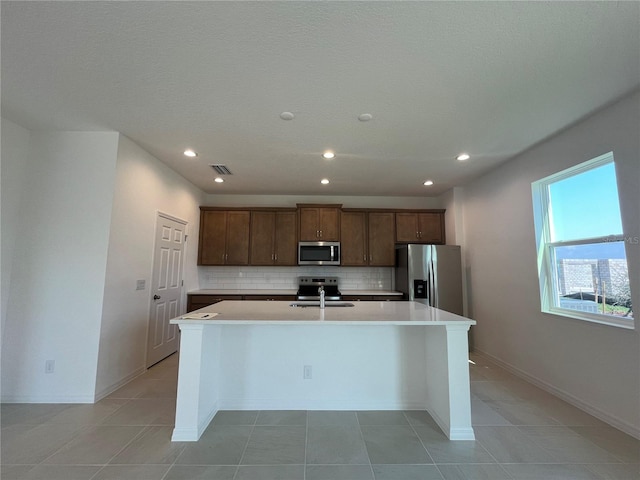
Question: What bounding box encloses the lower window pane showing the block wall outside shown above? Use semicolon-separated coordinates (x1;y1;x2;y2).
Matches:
553;242;633;318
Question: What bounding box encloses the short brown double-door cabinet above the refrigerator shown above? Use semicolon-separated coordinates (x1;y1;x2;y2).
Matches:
396;210;445;244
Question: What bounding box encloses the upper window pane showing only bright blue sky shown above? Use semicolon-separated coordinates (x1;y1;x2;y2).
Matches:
549;162;622;242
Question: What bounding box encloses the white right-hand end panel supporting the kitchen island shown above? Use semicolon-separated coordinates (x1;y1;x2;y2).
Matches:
425;325;475;440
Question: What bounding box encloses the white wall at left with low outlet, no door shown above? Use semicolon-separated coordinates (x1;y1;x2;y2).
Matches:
2;128;118;403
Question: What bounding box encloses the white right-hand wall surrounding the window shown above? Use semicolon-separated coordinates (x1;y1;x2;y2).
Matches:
463;93;640;436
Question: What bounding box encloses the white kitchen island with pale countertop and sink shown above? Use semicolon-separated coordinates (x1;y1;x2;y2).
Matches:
171;301;475;441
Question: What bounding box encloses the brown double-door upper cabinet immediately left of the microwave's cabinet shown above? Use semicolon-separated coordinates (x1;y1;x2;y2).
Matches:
250;209;297;265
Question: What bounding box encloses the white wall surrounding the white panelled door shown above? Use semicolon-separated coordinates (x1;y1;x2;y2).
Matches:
96;135;203;398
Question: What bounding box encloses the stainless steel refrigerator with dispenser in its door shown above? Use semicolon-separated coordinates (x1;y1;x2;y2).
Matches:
396;244;462;315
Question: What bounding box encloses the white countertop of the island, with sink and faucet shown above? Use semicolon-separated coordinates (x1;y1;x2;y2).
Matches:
171;300;476;325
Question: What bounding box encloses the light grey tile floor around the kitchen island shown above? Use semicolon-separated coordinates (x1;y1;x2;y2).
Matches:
0;355;640;480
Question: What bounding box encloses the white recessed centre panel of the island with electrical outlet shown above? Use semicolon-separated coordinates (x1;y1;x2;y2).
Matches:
219;323;425;410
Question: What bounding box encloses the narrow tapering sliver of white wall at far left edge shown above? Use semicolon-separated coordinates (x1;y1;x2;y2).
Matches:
0;119;30;337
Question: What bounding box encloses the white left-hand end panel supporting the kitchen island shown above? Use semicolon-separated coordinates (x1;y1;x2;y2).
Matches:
171;324;221;442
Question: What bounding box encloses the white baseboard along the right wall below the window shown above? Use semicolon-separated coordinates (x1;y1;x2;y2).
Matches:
473;348;640;440
